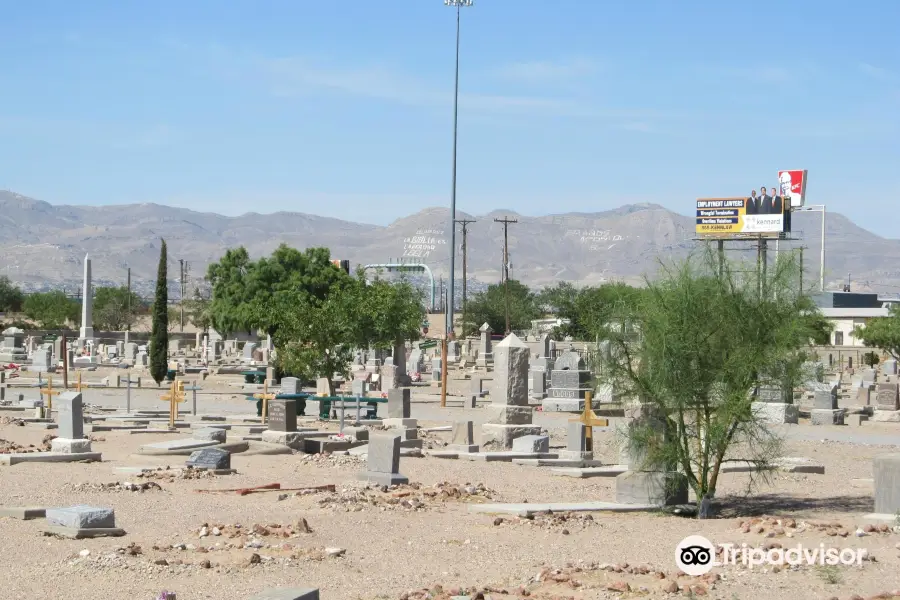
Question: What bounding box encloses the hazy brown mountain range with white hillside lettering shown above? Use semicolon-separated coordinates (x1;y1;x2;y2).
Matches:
0;191;900;295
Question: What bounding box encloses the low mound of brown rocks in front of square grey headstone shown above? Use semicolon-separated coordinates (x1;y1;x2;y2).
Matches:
318;482;496;512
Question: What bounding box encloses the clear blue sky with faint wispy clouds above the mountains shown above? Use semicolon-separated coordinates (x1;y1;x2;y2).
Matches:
0;0;900;237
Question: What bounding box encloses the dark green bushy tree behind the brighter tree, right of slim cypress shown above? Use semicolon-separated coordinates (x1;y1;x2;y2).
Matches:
207;244;351;335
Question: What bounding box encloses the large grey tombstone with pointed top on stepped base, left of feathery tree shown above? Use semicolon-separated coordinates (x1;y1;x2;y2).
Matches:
481;334;541;450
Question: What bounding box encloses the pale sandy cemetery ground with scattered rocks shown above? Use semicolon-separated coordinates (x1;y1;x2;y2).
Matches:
0;369;900;600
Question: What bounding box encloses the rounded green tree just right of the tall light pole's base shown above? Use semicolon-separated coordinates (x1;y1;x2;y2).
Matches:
465;279;542;334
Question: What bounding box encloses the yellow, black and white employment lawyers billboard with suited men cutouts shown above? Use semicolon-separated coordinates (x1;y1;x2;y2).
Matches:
696;192;791;237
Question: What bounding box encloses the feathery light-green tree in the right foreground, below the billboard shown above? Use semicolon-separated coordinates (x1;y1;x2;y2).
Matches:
600;246;825;517
